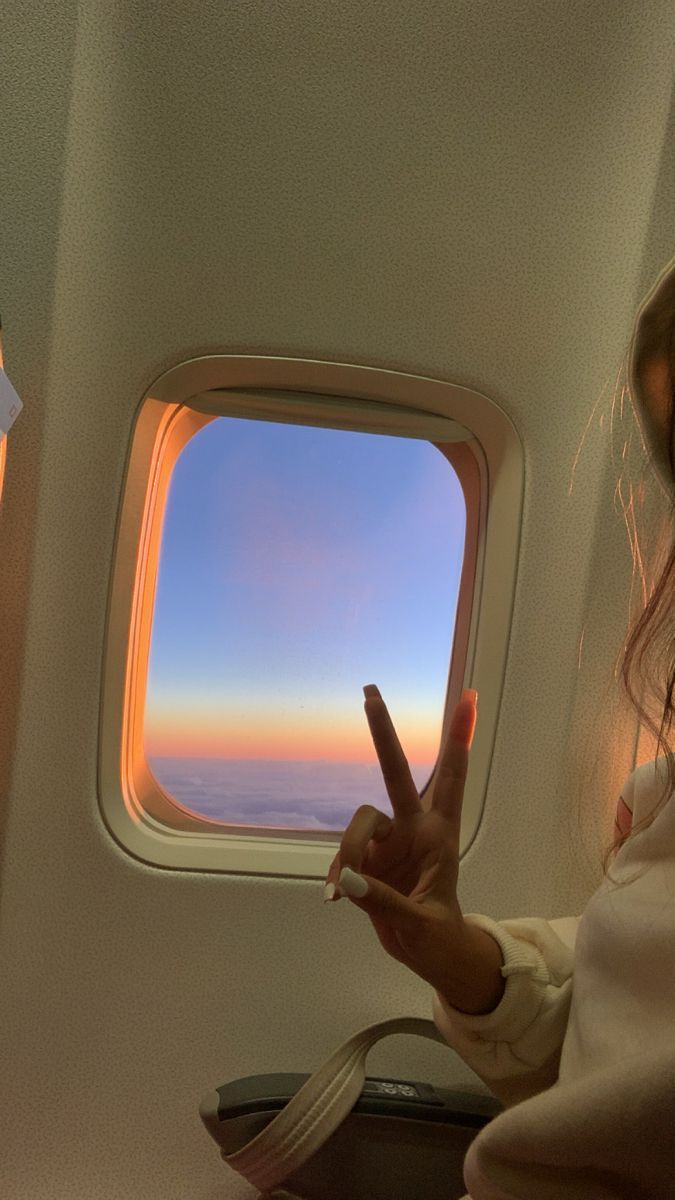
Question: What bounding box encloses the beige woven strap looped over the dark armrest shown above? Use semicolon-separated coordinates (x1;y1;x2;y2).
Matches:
222;1016;447;1192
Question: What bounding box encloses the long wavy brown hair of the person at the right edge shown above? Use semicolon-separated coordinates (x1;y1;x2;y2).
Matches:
603;268;675;883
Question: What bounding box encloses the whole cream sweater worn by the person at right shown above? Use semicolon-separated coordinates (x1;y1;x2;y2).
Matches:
434;758;675;1200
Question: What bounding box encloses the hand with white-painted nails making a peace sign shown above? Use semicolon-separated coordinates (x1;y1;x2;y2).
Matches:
325;684;503;1012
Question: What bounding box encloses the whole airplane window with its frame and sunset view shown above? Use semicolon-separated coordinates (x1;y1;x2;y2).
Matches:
98;354;524;878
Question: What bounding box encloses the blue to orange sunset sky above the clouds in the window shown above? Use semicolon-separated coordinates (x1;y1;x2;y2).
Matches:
145;418;465;763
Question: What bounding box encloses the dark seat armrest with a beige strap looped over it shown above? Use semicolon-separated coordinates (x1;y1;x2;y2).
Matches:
199;1018;502;1200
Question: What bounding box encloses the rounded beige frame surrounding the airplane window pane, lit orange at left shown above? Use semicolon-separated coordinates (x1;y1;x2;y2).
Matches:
98;355;524;878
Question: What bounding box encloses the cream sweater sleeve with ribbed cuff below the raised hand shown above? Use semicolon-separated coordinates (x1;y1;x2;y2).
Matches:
434;913;580;1108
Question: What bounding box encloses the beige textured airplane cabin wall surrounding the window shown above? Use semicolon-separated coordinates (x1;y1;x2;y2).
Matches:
0;0;675;1200
